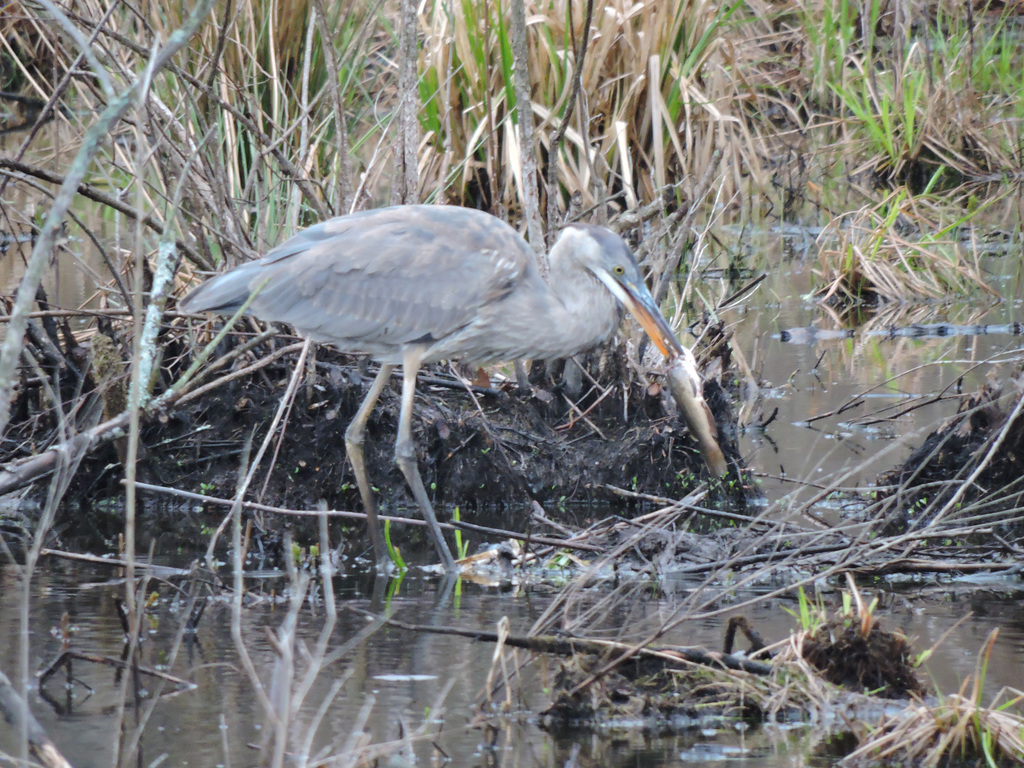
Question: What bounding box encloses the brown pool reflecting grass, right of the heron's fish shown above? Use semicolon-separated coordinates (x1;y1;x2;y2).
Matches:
705;230;1024;500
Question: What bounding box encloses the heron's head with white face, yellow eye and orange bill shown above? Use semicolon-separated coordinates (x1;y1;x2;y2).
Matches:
551;224;683;359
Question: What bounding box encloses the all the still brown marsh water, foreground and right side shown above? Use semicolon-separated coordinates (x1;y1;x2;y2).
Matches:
0;219;1024;766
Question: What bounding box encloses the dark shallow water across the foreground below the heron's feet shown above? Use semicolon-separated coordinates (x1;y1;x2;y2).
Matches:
0;561;1024;766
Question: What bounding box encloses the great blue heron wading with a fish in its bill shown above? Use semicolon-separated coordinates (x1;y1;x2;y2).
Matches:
180;206;683;571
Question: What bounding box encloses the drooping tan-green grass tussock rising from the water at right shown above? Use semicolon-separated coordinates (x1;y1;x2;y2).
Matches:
817;187;994;303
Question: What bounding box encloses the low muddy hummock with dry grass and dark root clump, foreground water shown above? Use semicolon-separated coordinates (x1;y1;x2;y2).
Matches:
543;606;931;731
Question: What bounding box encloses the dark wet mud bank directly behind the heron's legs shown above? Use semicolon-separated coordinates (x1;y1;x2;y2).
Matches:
4;337;748;548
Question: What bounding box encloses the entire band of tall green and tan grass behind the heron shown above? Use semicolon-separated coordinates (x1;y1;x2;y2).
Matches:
5;0;1024;256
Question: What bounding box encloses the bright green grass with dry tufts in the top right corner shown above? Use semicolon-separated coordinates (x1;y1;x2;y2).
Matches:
798;0;1024;189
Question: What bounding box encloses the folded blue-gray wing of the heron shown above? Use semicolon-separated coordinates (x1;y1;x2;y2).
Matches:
182;206;536;352
